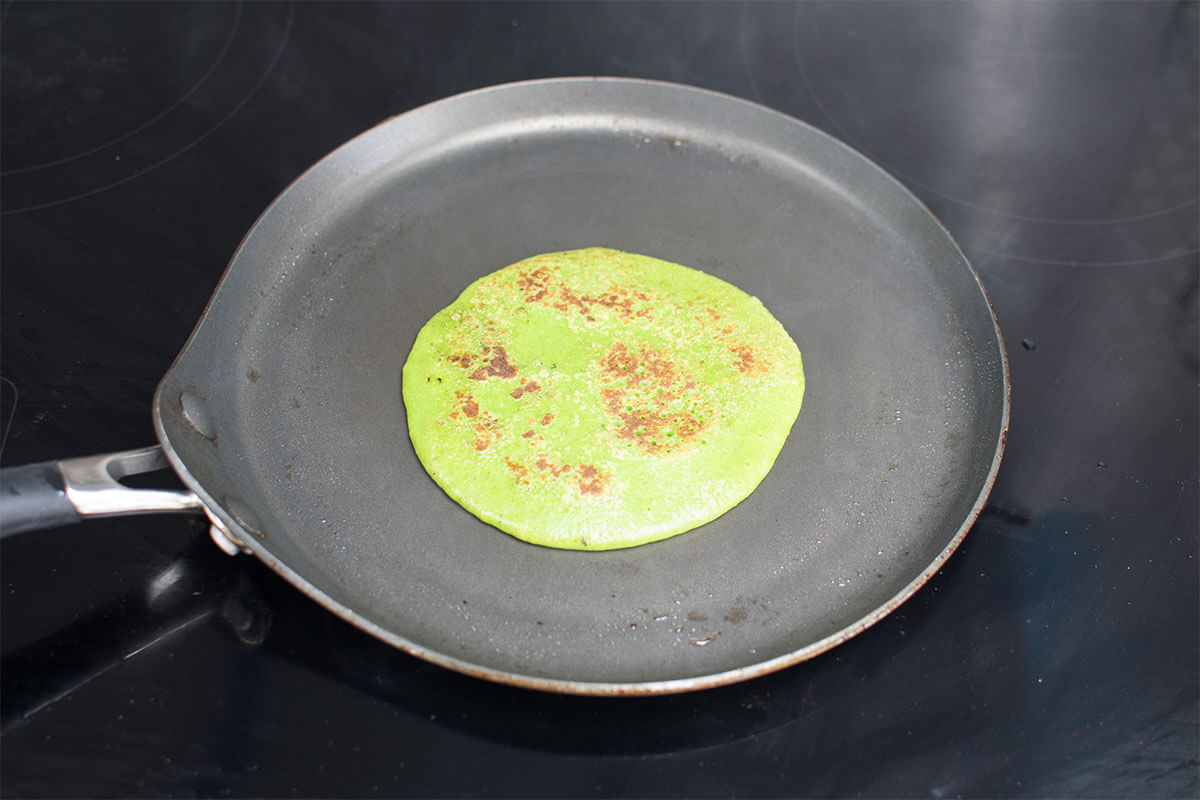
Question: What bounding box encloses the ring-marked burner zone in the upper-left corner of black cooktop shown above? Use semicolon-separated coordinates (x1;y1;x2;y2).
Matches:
0;4;293;213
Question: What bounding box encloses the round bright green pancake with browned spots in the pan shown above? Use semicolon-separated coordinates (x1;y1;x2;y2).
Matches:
403;248;804;551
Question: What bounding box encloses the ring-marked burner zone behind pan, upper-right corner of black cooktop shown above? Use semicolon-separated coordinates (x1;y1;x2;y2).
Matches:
787;4;1200;266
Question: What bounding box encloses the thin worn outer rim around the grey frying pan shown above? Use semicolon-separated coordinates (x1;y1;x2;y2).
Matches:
152;77;1012;696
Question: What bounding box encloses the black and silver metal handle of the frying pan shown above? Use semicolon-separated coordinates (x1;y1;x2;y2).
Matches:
0;445;204;536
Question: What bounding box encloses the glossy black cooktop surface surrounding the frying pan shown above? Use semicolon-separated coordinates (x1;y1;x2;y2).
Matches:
0;1;1200;798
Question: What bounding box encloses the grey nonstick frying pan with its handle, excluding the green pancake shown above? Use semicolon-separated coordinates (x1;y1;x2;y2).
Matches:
4;78;1008;694
